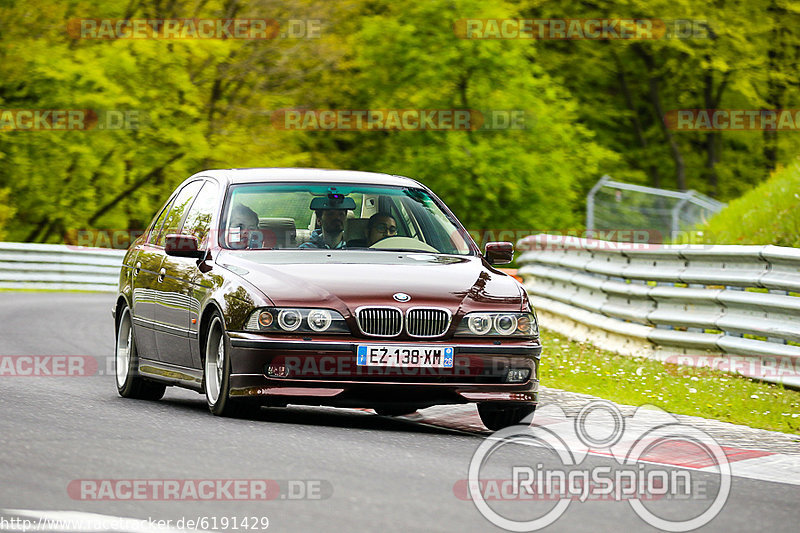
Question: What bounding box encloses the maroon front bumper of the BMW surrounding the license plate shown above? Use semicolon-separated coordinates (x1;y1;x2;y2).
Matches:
222;332;542;408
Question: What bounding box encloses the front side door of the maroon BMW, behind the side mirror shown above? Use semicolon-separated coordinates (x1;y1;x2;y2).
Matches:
154;179;204;368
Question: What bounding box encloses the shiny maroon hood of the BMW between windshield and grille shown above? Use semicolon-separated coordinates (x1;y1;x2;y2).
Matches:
217;250;524;313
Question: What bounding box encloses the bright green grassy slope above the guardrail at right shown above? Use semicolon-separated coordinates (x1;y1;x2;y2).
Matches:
701;162;800;247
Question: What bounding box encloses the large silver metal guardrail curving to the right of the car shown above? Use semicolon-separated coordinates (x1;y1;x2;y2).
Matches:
517;234;800;387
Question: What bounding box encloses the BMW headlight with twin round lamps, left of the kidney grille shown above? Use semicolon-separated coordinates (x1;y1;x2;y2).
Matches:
244;307;350;333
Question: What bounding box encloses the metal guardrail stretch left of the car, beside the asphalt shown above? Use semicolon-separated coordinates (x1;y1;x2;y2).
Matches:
0;242;125;292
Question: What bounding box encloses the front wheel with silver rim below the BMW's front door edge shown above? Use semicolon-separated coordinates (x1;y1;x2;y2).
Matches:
203;311;261;418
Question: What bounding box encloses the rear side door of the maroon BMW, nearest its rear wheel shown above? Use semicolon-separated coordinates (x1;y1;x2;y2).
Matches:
131;193;173;360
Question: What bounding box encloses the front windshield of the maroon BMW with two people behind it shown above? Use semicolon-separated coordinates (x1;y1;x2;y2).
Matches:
221;183;473;255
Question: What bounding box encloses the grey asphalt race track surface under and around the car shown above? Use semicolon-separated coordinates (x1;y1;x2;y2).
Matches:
0;292;800;532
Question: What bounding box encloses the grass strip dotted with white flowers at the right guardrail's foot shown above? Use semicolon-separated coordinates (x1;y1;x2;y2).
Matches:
540;330;800;436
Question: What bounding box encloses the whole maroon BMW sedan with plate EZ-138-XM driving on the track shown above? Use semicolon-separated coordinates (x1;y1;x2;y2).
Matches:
113;168;541;429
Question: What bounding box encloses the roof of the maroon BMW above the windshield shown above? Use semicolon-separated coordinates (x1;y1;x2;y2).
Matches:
192;168;422;187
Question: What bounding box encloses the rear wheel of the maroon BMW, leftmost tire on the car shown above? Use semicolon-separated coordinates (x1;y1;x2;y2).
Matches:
114;306;167;400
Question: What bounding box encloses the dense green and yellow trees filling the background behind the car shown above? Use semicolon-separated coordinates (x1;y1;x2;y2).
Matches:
0;0;800;242
